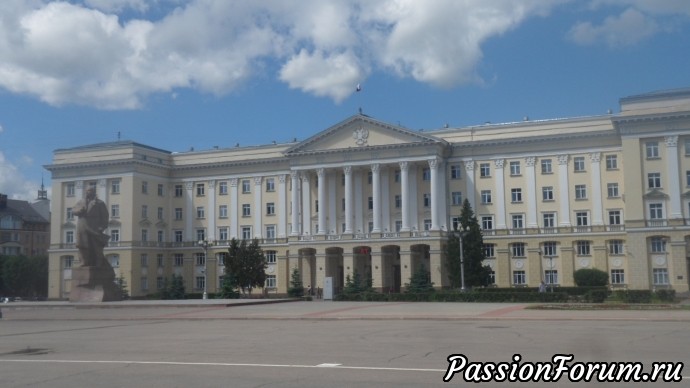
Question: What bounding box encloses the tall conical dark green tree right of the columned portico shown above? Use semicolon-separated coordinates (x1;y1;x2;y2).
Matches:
446;199;491;288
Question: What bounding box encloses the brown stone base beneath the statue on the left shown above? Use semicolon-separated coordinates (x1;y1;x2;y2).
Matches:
69;267;122;302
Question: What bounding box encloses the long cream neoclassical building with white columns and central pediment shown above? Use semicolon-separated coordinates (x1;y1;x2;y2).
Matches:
46;89;690;299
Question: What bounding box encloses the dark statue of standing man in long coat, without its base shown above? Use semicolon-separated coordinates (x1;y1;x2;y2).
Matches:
72;187;110;267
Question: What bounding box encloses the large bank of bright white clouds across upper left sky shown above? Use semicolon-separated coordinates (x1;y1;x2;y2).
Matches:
0;0;562;109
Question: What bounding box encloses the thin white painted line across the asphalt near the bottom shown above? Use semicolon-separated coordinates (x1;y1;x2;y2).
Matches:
0;359;446;372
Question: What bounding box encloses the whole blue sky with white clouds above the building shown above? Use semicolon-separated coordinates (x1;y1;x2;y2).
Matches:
0;0;690;200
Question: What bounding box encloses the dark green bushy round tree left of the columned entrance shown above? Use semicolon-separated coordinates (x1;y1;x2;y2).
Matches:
224;238;267;294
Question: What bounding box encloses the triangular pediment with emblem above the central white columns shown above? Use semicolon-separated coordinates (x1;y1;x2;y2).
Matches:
285;115;445;155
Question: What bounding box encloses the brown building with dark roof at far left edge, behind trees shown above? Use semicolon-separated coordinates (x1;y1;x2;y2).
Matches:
0;187;50;256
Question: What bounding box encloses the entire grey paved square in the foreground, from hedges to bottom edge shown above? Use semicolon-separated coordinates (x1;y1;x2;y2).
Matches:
0;302;690;388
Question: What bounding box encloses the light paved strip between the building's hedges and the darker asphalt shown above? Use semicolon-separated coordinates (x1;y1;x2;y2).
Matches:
0;299;690;322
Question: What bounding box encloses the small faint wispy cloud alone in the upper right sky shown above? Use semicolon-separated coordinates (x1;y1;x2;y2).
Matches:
568;8;659;47
